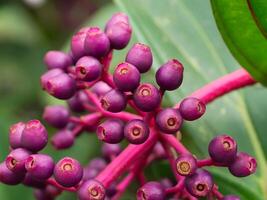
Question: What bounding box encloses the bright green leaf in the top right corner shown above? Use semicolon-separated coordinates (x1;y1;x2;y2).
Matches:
211;0;267;85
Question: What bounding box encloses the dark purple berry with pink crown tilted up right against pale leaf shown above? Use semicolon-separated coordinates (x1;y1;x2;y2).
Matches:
156;59;184;91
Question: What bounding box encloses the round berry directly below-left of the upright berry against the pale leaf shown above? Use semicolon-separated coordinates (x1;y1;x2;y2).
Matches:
113;62;141;92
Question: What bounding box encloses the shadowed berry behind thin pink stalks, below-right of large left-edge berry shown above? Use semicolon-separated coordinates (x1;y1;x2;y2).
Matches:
68;91;89;112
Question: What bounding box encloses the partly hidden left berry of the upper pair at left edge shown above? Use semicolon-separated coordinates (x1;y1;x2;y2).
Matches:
9;122;25;149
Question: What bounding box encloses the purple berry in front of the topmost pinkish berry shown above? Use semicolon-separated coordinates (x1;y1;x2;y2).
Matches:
105;21;132;49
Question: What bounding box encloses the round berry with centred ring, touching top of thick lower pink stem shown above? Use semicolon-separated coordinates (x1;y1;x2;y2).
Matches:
124;119;149;144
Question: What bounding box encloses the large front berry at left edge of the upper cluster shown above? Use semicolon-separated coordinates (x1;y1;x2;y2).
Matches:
45;73;76;100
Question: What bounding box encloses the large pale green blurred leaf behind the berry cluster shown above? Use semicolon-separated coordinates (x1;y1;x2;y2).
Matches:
115;0;267;200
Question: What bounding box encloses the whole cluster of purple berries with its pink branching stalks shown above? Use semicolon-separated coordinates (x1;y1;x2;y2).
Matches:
0;13;257;200
